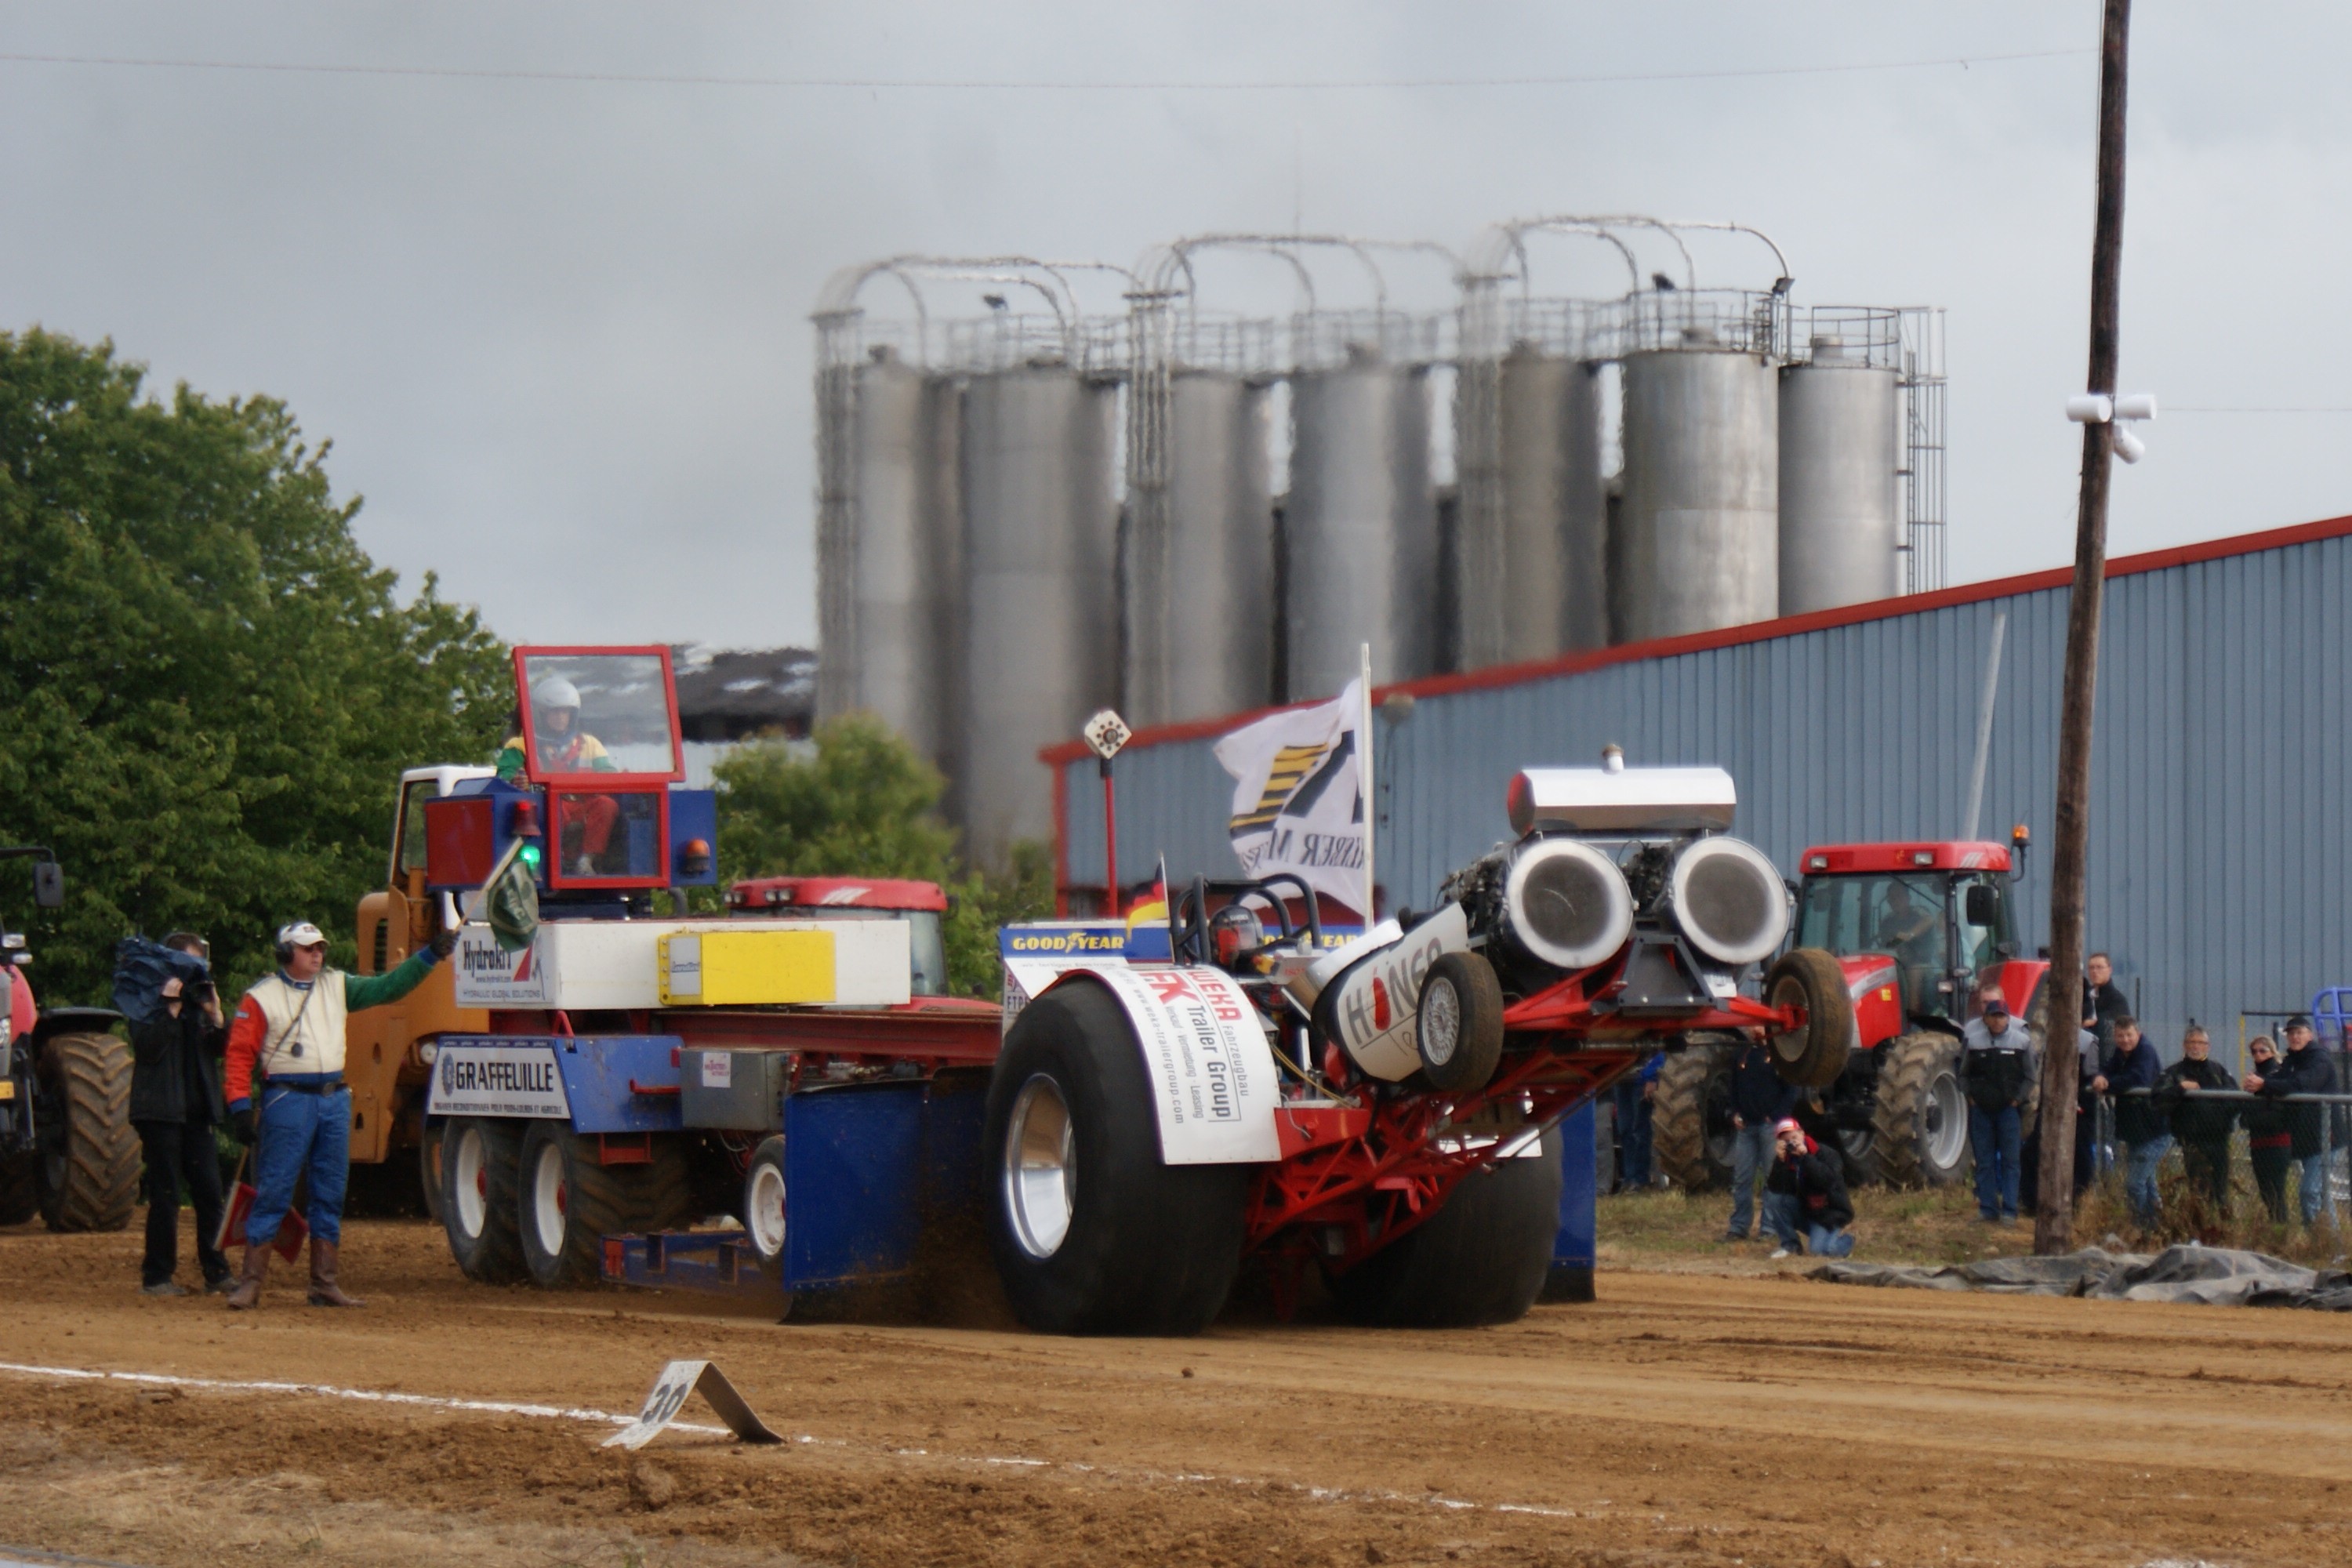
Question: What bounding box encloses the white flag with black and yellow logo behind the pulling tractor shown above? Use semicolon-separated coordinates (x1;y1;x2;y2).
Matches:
1216;682;1364;909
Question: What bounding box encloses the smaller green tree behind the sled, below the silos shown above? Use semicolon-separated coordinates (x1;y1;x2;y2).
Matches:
713;713;1054;996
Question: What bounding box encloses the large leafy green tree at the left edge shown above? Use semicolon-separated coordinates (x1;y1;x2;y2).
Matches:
0;329;510;1001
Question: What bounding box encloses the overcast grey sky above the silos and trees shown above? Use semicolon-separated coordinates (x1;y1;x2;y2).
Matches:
0;0;2352;647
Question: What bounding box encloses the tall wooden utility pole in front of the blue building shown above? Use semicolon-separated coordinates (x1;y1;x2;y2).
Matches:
2034;0;2131;1255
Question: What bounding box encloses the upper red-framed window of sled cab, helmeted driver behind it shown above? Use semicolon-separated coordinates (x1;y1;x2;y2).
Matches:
515;649;684;783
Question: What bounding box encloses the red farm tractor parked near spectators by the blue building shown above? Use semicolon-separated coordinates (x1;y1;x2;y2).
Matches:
1653;827;2049;1189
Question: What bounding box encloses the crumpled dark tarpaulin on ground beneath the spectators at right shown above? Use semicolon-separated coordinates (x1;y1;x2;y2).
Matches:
1809;1241;2352;1312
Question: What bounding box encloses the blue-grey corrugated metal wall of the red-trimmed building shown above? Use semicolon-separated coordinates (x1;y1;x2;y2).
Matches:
1063;534;2352;1060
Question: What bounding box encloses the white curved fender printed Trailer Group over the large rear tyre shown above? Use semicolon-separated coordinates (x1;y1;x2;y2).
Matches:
1049;961;1282;1166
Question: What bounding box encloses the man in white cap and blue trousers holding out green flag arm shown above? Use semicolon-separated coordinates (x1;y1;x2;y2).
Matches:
228;919;456;1312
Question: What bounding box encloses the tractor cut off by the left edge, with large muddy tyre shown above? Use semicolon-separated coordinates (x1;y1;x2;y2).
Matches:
0;844;139;1229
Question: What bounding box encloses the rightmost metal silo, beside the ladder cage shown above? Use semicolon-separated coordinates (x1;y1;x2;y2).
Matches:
1780;328;1903;616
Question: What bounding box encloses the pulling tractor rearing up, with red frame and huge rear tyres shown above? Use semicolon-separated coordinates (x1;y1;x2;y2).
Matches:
981;753;1853;1333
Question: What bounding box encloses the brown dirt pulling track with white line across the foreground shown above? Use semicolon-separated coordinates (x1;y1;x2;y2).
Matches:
0;1220;2352;1568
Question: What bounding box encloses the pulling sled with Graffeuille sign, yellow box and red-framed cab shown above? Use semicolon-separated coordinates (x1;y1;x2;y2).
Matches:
346;647;997;1288
